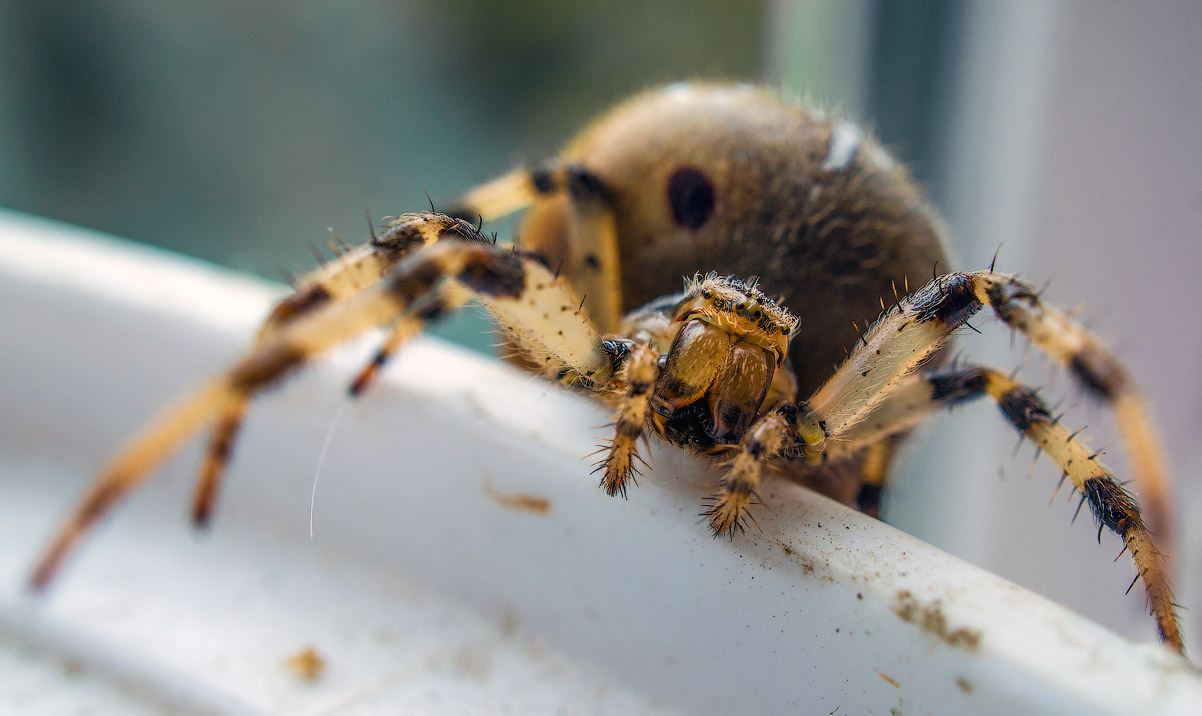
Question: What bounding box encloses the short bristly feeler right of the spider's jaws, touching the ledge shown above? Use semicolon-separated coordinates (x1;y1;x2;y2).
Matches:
702;407;796;539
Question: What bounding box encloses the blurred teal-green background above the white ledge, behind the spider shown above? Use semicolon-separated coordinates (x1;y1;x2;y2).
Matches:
0;0;956;350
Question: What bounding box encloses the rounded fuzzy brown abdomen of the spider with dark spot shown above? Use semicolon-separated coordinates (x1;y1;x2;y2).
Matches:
522;83;951;394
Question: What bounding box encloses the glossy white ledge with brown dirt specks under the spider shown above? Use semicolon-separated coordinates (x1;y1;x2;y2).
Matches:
0;210;1202;716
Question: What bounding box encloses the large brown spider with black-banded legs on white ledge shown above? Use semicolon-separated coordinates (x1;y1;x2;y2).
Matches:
31;83;1184;651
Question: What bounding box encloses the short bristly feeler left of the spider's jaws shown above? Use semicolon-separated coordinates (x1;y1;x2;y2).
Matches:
595;345;660;497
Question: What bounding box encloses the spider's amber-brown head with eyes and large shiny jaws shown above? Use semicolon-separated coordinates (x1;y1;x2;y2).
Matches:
651;274;797;444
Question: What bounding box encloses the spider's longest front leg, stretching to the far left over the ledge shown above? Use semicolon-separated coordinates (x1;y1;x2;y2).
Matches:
30;214;614;590
